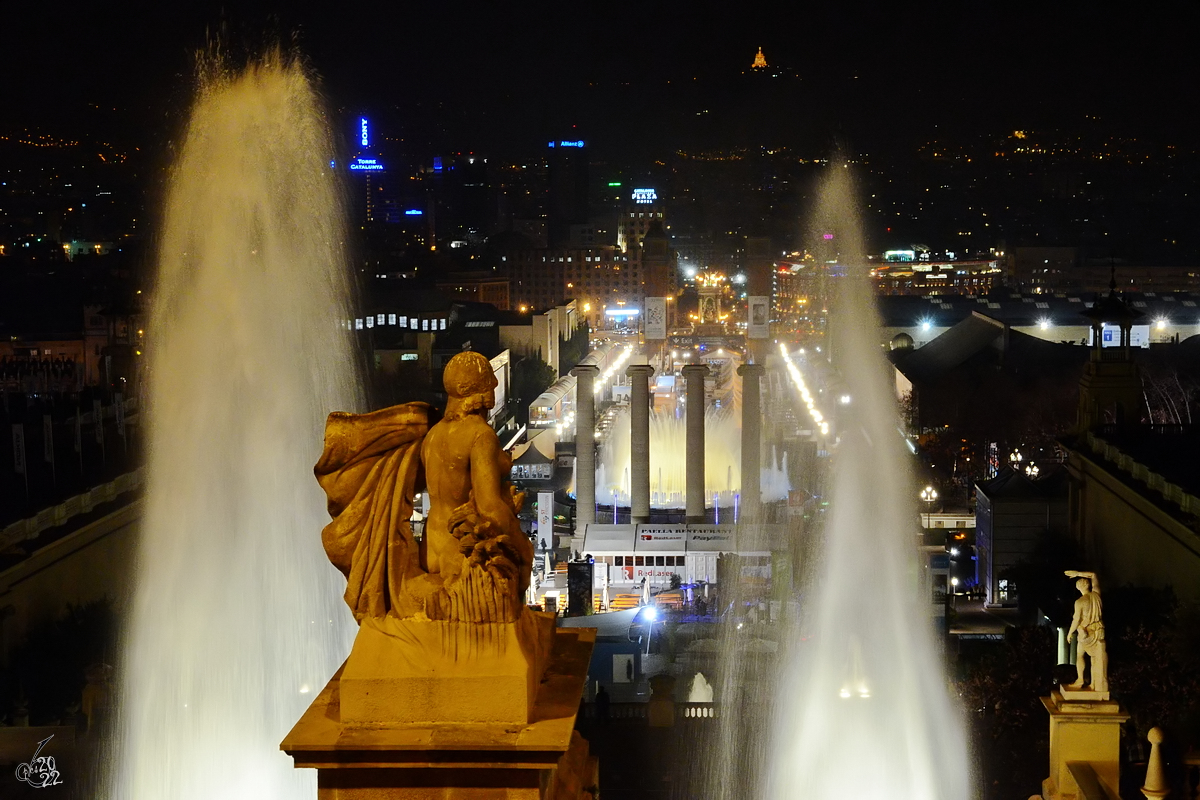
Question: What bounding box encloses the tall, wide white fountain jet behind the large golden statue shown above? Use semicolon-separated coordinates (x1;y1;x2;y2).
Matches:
107;55;360;800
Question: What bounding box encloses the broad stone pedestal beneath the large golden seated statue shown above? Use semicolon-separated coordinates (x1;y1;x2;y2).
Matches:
281;620;596;800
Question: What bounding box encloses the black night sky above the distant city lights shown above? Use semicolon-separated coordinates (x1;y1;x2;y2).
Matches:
0;0;1200;156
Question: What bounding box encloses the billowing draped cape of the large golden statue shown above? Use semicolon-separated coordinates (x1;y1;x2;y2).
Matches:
313;403;430;622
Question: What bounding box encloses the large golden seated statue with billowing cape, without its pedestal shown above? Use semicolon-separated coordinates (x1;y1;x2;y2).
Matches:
314;351;533;622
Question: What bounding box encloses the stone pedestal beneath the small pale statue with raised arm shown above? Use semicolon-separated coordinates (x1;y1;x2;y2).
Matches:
1042;688;1129;800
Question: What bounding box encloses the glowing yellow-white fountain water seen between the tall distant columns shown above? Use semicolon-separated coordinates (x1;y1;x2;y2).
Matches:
596;409;791;510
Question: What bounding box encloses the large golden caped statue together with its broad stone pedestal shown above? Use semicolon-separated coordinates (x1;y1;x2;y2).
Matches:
281;353;596;800
